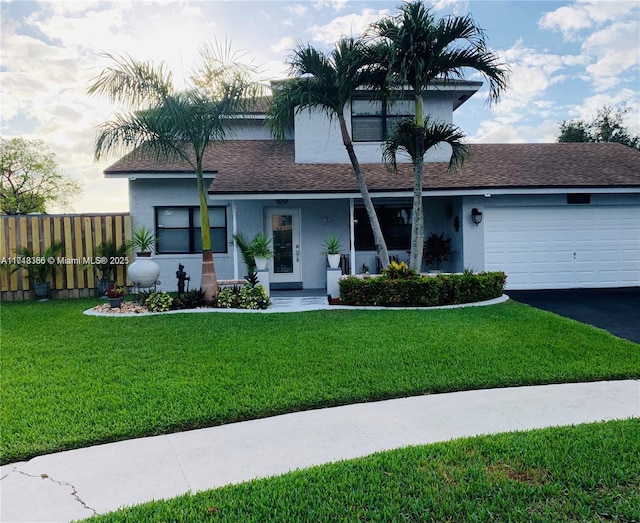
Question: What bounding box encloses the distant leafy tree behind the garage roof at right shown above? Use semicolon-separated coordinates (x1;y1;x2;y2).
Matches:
558;105;640;150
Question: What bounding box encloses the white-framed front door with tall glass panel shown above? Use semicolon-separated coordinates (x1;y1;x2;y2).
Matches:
265;208;302;289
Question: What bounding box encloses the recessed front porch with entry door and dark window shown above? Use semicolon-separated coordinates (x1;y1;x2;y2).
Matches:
225;195;463;294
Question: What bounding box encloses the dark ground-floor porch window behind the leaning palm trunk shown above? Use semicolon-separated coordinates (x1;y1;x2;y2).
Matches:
354;204;411;251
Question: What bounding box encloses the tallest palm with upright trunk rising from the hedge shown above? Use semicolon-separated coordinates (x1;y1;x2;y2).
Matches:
371;1;508;270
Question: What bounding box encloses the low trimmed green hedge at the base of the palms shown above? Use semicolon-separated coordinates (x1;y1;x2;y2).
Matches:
339;272;507;307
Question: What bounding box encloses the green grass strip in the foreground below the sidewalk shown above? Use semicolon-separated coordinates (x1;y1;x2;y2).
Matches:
84;419;640;523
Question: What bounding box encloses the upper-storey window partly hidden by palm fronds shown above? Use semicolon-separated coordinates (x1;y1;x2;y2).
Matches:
351;98;415;142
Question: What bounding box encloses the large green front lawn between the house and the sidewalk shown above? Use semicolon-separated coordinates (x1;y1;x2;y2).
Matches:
0;300;640;463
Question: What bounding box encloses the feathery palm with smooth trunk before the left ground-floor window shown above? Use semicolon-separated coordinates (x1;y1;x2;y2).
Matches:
88;44;256;301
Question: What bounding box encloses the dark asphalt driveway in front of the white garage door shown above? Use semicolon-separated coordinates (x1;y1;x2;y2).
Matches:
506;287;640;343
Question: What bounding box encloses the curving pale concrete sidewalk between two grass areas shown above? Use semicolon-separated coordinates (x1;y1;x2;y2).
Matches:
0;380;640;523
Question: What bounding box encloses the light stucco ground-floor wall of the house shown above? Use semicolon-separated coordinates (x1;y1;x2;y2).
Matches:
129;178;640;290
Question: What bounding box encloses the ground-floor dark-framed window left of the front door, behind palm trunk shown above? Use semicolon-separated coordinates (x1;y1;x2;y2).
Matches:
155;207;227;254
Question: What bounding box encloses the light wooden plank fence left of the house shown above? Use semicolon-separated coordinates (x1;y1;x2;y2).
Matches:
0;214;133;301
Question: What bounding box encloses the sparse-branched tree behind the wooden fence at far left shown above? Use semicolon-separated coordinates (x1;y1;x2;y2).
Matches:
0;138;82;214
